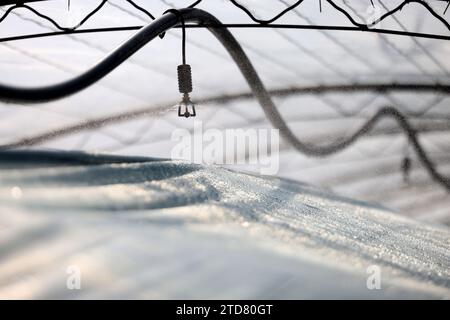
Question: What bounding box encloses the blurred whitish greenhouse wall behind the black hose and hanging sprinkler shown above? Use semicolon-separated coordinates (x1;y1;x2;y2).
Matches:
0;0;450;225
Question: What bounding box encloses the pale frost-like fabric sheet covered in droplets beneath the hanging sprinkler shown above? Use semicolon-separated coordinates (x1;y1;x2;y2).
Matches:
0;152;450;299
